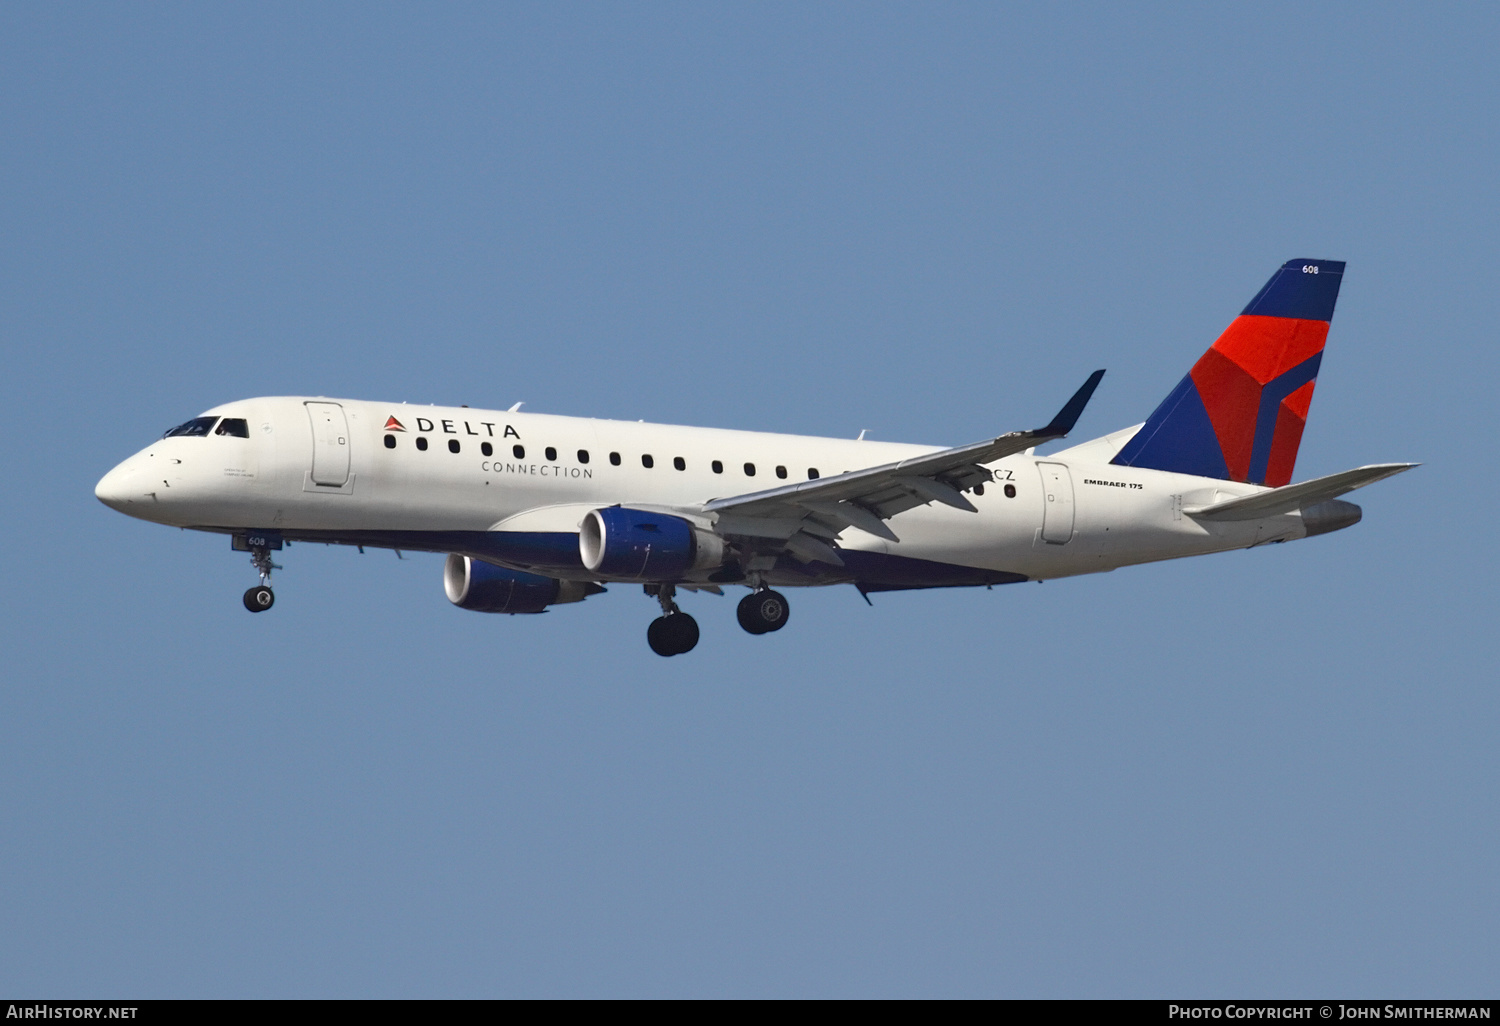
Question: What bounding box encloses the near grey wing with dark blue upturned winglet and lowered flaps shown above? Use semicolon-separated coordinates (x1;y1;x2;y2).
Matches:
702;371;1104;566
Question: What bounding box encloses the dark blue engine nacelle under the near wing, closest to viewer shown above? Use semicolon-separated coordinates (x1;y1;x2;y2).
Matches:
578;506;725;581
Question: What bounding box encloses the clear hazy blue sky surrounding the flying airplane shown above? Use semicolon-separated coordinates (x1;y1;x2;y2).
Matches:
0;3;1500;998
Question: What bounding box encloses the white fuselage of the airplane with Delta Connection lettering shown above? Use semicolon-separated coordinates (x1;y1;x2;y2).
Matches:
98;398;1307;585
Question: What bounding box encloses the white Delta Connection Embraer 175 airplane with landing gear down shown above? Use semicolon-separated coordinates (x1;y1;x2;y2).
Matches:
95;260;1418;656
